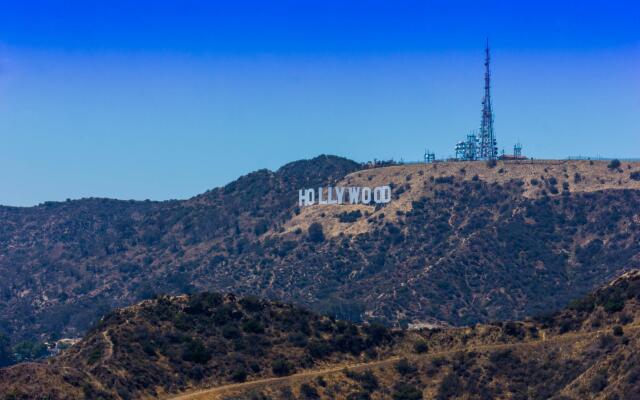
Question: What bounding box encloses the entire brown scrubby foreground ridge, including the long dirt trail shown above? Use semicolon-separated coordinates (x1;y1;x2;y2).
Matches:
0;271;640;400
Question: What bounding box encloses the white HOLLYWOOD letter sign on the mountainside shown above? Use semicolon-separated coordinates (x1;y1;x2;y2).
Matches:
298;186;391;207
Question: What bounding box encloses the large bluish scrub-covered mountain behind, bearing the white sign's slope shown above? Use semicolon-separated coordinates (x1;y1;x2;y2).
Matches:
0;156;640;354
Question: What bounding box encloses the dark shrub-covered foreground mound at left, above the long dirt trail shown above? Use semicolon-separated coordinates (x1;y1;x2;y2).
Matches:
0;293;399;399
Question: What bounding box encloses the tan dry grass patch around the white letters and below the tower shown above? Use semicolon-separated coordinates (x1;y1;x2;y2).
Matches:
285;161;640;237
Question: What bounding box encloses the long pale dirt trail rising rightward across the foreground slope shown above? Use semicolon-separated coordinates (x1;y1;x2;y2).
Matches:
170;325;640;400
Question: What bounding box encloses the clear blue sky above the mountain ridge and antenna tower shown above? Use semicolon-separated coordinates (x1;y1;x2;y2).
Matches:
0;0;640;206
